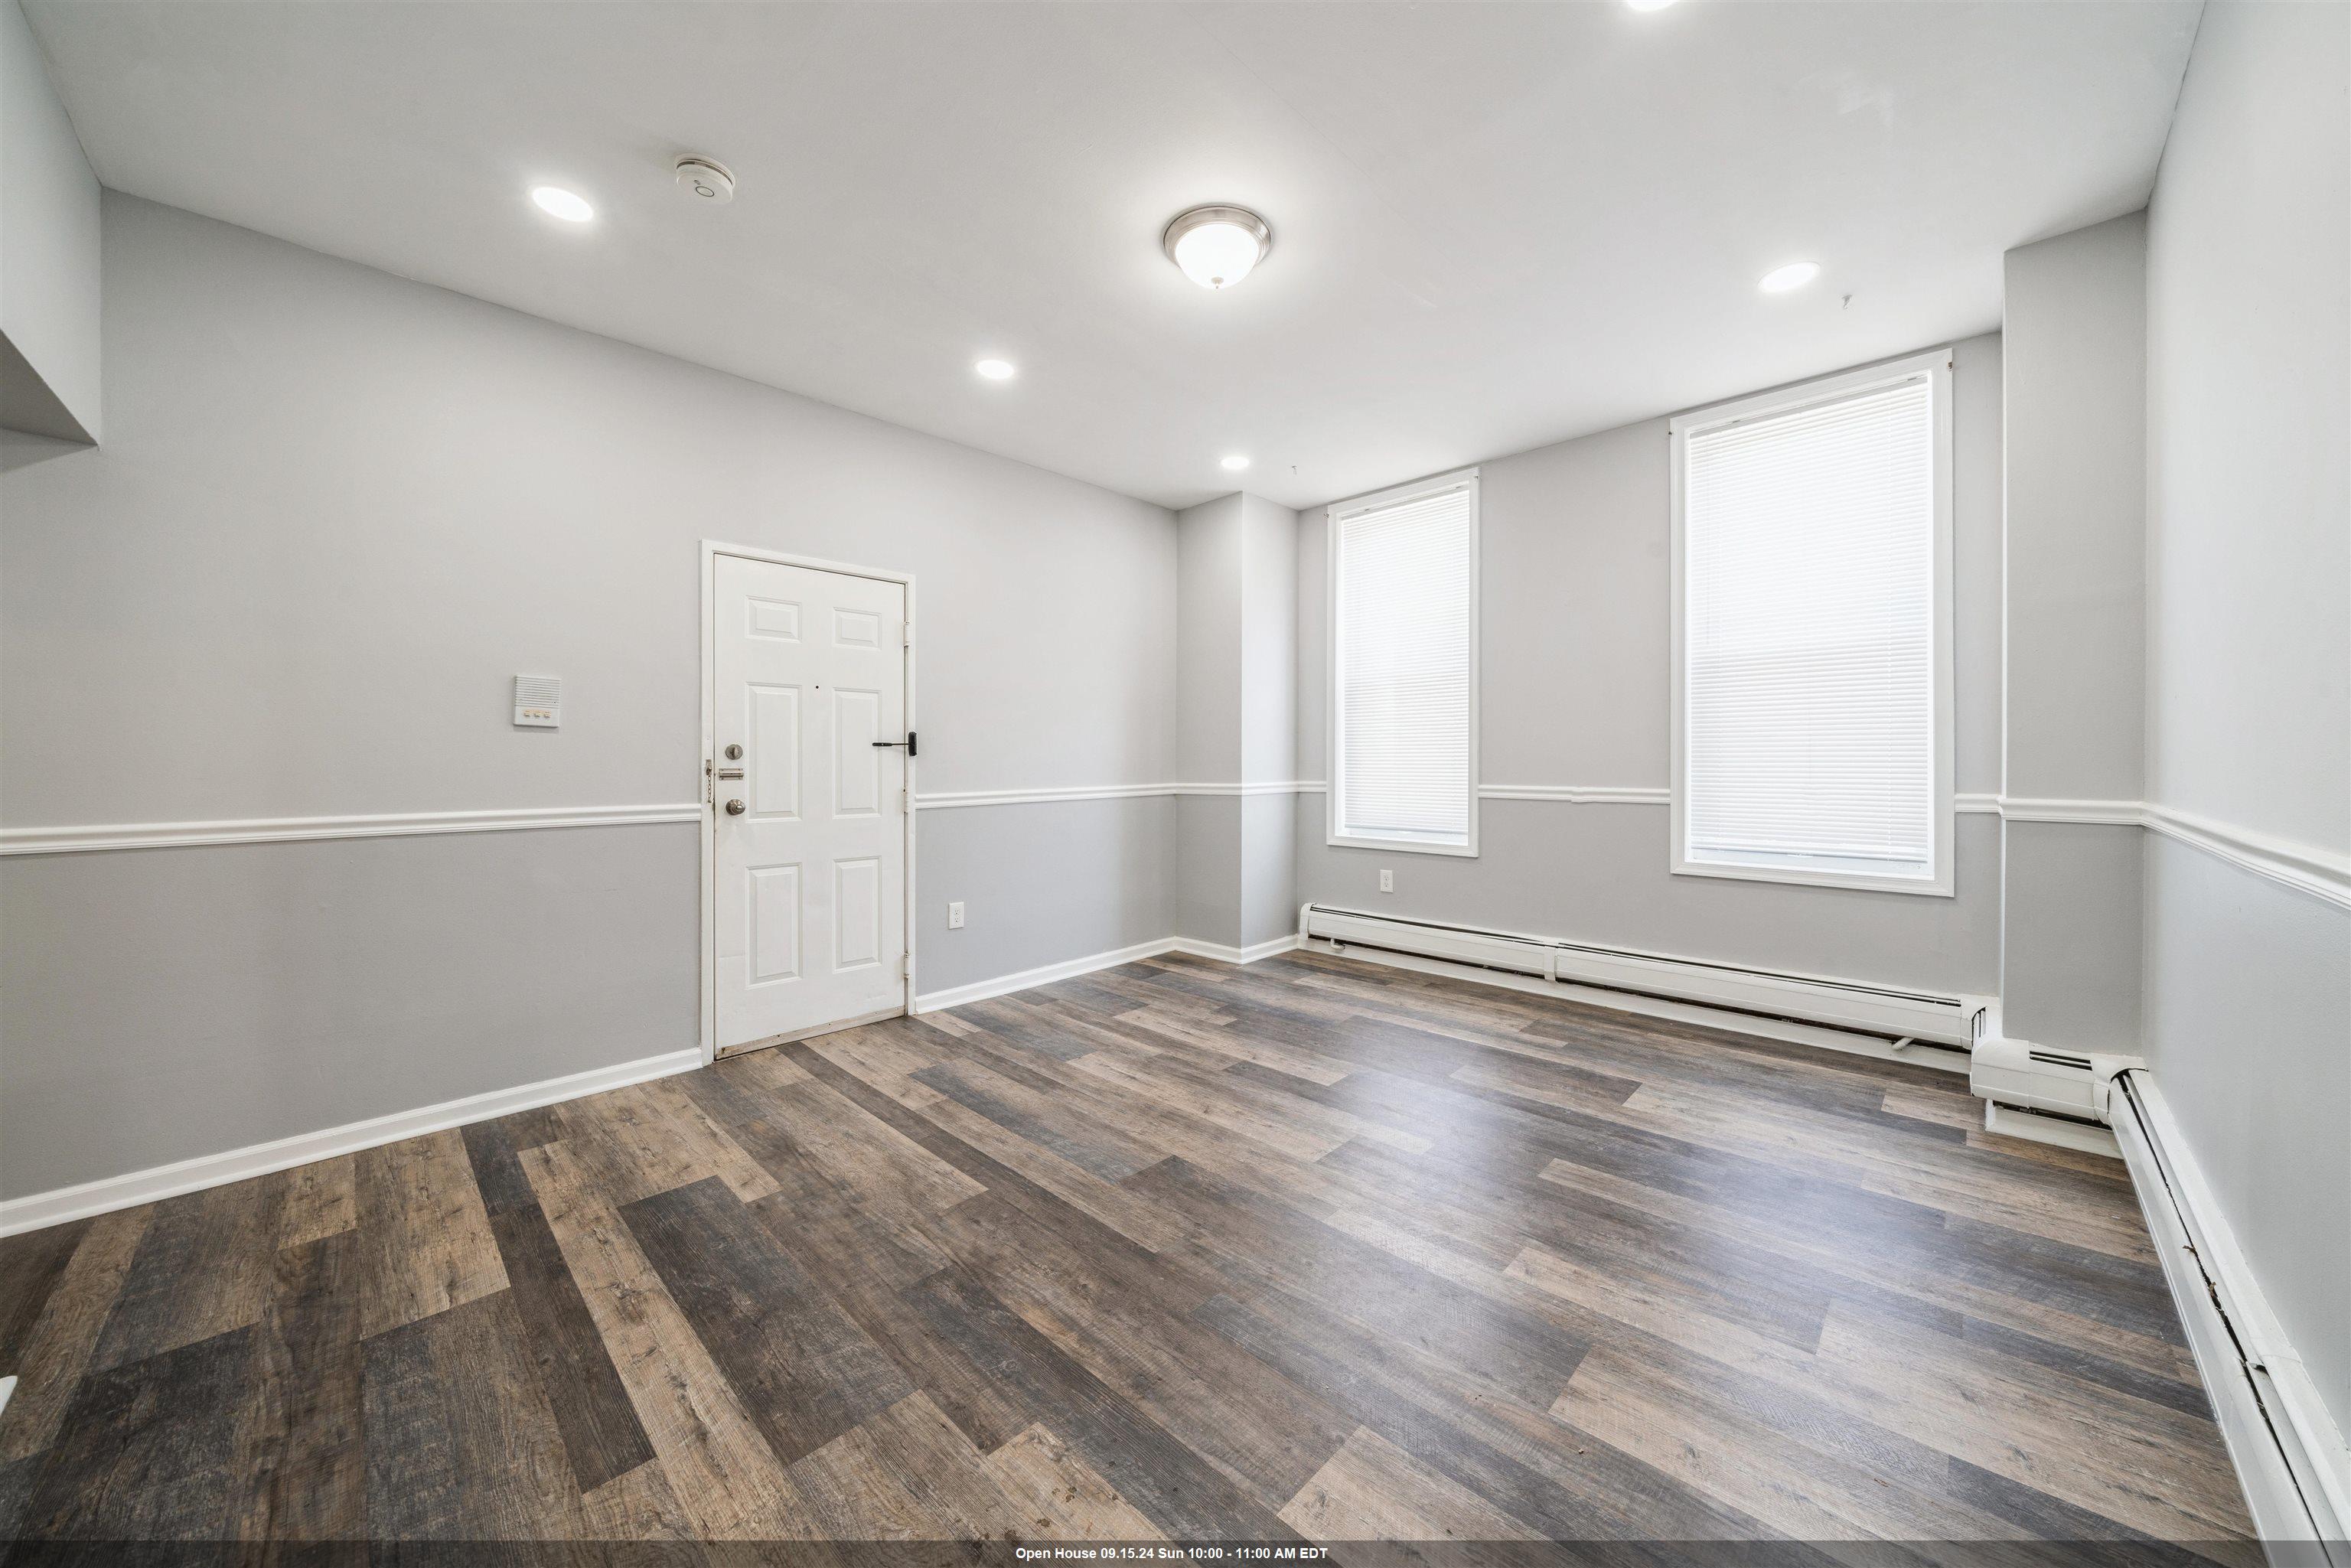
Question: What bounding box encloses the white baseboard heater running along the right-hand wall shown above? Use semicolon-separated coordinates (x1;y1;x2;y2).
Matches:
2111;1070;2351;1563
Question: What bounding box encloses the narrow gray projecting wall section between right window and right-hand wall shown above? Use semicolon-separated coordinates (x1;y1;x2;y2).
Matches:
2000;214;2147;1055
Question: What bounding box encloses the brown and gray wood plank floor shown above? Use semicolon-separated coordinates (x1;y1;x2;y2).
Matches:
0;954;2257;1563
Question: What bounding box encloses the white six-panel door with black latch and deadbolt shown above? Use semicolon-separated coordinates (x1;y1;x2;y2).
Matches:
710;555;908;1053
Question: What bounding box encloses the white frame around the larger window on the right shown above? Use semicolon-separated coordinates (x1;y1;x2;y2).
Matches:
1669;348;1956;898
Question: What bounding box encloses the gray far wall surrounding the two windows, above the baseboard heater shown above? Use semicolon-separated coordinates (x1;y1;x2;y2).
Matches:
1298;336;2000;992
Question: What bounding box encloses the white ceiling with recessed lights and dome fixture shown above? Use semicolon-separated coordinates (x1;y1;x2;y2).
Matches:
26;0;2198;505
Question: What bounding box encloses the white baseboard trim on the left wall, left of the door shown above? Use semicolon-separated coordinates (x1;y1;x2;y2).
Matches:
0;1046;703;1237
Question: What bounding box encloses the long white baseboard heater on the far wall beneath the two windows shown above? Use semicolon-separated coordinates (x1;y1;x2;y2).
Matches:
1298;903;1991;1051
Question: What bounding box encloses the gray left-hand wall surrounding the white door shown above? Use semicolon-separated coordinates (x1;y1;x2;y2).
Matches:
0;195;1176;1197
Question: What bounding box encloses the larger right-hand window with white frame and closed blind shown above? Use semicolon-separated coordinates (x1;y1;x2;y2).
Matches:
1671;350;1952;893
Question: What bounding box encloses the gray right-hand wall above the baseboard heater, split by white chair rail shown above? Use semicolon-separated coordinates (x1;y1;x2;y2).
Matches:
2147;5;2351;1432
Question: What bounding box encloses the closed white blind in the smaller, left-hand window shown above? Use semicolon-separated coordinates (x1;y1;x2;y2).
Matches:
1331;480;1476;853
